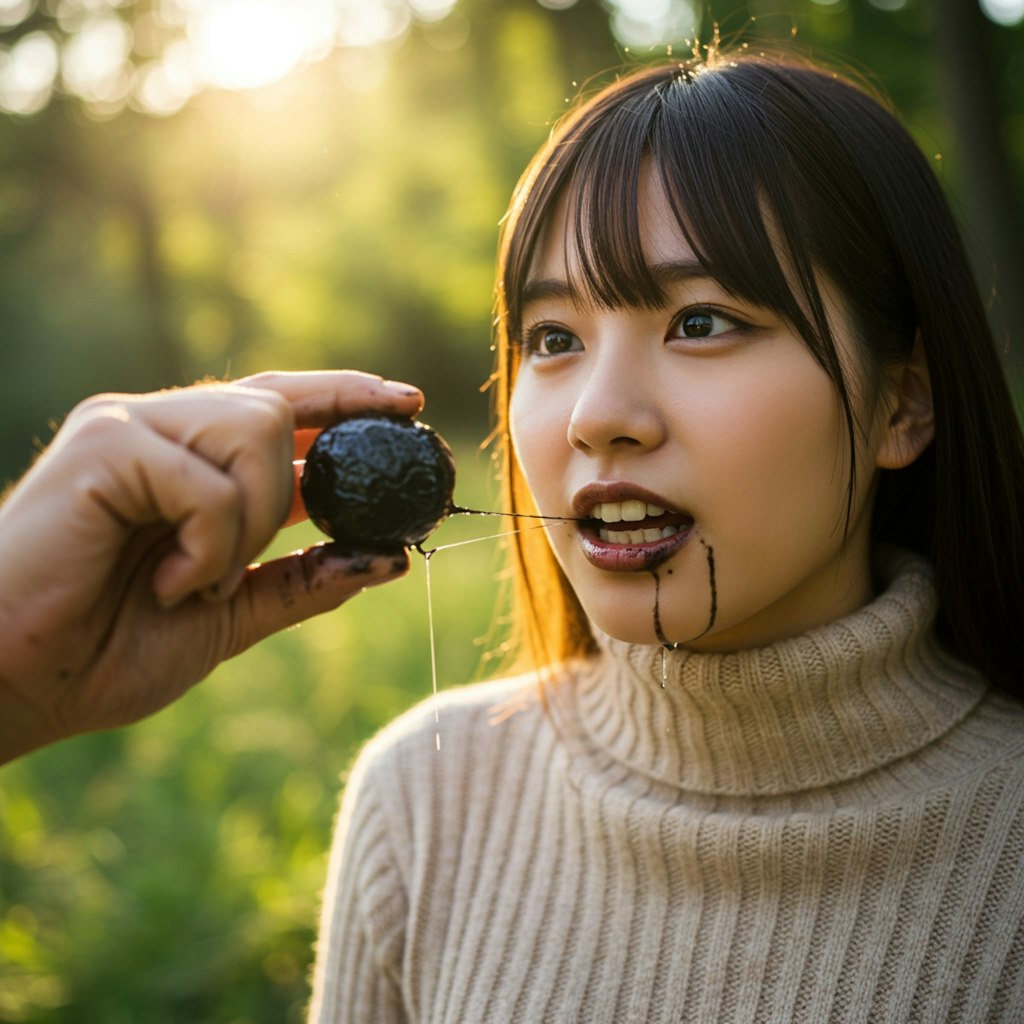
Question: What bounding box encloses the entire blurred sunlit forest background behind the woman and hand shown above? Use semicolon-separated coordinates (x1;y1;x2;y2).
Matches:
0;0;1024;1024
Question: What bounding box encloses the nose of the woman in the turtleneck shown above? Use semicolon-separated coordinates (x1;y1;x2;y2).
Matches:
567;353;665;453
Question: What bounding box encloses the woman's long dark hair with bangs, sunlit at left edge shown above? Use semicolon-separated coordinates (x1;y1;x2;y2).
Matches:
496;54;1024;695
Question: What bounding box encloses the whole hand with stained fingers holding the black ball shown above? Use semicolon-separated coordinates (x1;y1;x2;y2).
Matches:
0;371;423;763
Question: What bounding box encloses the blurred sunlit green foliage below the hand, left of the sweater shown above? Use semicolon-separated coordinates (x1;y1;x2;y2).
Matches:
0;442;509;1024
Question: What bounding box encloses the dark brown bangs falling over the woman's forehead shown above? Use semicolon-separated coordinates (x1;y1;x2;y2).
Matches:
495;58;842;379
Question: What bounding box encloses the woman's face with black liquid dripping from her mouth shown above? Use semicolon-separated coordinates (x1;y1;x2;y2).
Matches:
510;167;886;650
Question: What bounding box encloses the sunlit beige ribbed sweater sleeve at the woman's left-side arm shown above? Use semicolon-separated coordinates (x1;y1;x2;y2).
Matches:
309;751;408;1024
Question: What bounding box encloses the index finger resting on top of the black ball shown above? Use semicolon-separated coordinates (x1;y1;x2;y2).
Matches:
236;370;423;429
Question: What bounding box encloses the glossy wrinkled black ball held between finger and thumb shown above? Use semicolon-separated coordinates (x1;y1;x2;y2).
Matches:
301;416;455;551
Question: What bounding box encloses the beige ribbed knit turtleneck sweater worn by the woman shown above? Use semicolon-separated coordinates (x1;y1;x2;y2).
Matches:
312;555;1024;1024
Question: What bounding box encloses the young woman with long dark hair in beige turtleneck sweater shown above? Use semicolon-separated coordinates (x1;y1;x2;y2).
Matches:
312;56;1024;1024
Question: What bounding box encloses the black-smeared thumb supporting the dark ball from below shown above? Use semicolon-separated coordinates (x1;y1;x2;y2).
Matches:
226;544;409;657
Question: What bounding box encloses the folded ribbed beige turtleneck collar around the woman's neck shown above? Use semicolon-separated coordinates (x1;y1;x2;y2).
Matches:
552;552;986;796
